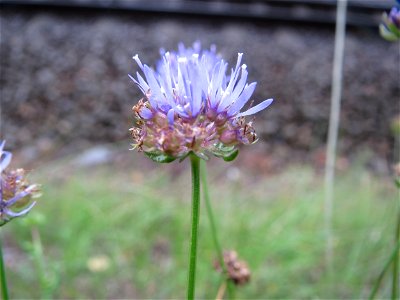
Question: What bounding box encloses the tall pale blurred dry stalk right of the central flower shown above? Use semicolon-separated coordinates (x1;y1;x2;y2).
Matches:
324;0;347;278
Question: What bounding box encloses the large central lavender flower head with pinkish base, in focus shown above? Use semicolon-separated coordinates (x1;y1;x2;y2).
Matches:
130;43;272;162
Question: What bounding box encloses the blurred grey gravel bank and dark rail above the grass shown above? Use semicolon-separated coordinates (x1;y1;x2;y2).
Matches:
0;0;399;168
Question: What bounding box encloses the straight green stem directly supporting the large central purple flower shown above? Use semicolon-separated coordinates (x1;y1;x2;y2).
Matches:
187;154;200;300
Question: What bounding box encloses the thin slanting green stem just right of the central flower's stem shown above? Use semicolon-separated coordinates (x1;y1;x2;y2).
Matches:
201;161;235;299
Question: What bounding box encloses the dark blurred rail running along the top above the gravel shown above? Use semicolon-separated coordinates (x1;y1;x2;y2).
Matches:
0;0;394;27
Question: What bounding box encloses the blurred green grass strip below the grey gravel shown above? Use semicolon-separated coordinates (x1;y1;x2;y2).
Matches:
2;156;398;299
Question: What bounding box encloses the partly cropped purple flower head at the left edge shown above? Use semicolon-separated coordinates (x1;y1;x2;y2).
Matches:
0;141;39;226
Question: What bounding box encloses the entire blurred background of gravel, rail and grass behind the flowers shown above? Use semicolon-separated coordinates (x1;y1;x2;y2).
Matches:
0;0;400;298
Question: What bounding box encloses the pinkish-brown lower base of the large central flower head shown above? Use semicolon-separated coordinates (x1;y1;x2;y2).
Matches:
130;98;257;158
